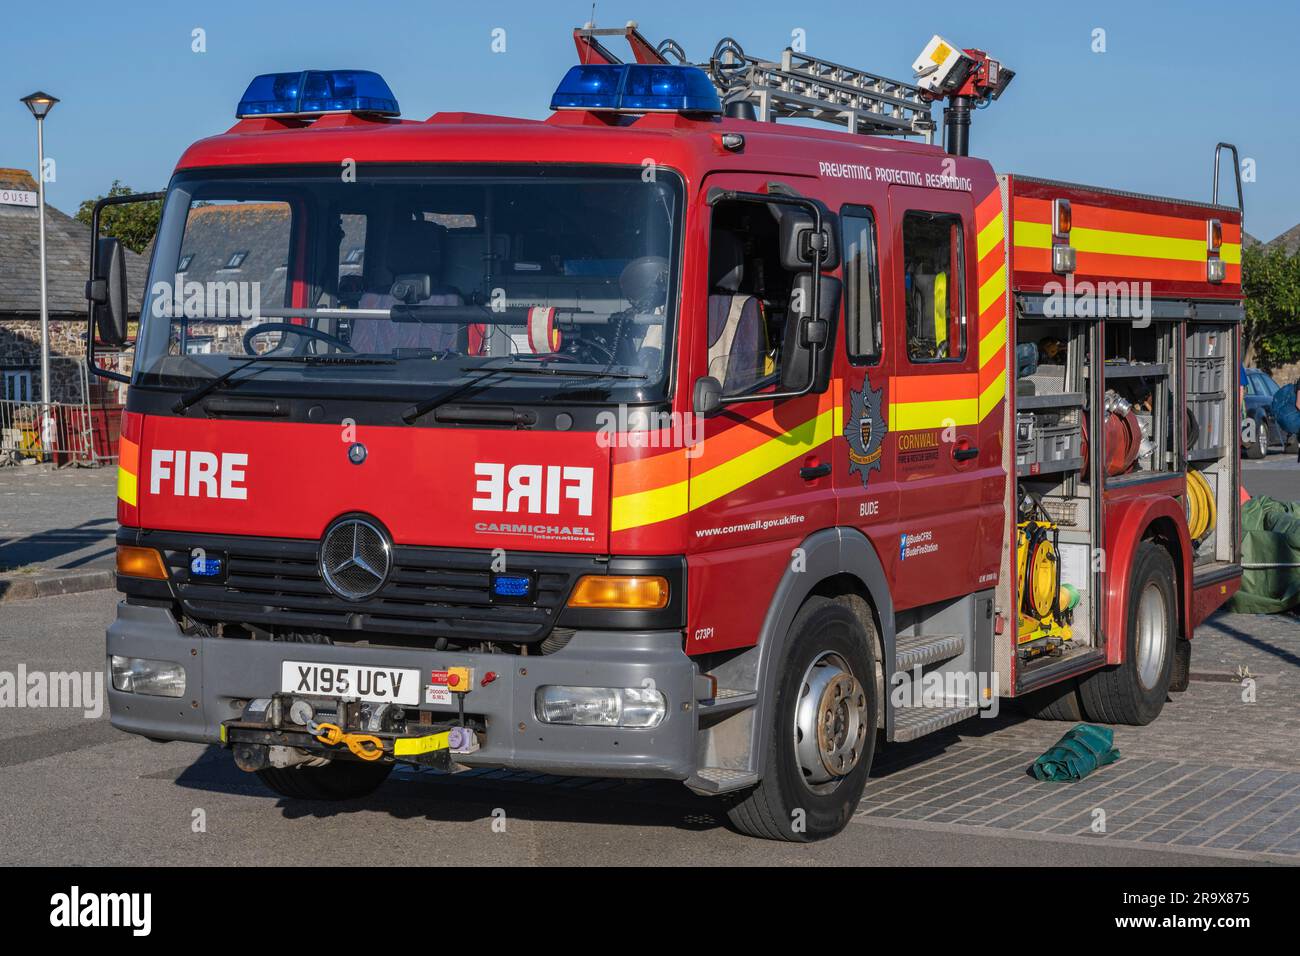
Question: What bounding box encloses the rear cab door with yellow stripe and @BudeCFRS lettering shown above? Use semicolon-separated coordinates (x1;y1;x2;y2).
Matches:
884;186;983;609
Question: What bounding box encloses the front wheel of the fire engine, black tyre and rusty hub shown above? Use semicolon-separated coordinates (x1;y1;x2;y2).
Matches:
727;597;878;843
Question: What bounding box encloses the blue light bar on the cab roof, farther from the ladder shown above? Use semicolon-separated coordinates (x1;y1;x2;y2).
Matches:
235;70;400;120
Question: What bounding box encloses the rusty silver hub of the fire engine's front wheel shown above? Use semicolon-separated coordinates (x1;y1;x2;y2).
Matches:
794;654;870;787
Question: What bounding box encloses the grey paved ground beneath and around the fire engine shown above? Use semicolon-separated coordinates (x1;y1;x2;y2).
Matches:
0;592;1300;866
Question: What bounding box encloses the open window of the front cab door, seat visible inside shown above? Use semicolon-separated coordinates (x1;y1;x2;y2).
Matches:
707;200;794;395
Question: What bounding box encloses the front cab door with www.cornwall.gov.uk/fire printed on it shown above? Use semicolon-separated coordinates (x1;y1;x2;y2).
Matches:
685;174;844;653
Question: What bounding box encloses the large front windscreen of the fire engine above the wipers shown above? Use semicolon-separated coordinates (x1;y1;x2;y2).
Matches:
134;165;681;403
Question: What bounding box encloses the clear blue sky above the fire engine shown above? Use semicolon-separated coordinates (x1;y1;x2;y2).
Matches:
0;0;1300;239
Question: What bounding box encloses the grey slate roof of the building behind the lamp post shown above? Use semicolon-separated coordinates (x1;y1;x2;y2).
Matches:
0;169;148;319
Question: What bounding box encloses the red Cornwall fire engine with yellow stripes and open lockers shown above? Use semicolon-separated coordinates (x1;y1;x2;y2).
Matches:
87;25;1243;840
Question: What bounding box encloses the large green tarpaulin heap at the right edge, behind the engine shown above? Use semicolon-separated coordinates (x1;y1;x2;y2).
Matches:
1227;494;1300;614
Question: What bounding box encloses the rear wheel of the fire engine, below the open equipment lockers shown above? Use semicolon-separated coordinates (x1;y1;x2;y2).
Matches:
1079;541;1178;726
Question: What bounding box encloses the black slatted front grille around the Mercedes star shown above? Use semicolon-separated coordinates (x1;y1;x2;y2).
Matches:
140;532;603;644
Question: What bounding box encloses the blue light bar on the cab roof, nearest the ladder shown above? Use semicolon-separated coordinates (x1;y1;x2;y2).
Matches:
551;64;723;116
